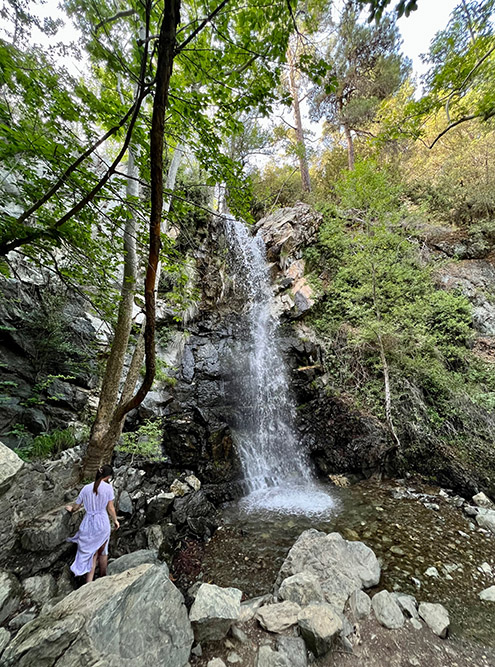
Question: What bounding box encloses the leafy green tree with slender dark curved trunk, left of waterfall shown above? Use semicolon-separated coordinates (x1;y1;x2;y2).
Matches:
3;0;298;474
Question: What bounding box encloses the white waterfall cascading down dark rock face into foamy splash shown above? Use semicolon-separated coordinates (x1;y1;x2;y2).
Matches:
225;216;334;514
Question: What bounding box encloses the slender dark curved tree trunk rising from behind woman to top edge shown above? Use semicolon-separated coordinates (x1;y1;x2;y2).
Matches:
83;0;180;476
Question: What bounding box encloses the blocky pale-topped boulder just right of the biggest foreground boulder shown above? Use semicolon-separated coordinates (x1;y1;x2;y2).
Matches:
189;584;242;642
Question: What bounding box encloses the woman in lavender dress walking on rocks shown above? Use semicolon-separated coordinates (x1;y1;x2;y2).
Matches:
65;465;120;583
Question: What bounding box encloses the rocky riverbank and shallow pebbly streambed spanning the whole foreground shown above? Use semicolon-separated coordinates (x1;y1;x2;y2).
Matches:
0;438;495;667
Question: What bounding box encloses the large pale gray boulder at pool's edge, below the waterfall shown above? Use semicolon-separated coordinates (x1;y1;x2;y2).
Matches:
277;529;380;612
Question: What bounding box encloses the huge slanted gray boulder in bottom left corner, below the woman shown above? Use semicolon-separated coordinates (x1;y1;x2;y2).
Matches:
2;564;193;667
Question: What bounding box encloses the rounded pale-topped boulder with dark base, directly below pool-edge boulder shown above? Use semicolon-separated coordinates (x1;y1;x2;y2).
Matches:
297;603;342;657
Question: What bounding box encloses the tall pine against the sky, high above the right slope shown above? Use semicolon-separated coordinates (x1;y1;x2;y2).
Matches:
310;0;408;170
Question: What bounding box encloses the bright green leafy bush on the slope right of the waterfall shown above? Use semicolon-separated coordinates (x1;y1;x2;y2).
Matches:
306;164;495;428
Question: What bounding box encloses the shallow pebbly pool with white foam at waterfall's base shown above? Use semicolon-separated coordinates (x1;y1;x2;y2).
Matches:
200;480;495;645
